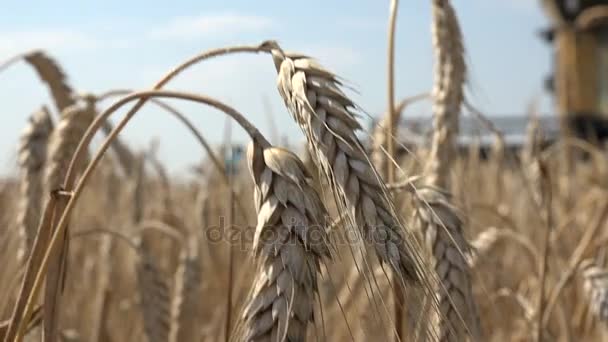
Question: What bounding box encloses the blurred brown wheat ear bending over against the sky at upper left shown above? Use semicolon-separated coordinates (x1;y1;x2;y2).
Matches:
25;51;76;112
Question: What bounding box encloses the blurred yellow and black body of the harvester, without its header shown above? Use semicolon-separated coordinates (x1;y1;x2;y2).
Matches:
542;0;608;140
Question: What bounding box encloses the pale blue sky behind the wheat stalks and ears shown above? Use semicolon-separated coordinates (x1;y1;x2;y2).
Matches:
0;0;550;173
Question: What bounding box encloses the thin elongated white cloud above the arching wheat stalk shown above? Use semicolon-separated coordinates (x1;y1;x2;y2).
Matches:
149;13;272;40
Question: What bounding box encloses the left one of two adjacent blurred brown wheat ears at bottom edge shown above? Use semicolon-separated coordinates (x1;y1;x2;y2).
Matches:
136;238;171;342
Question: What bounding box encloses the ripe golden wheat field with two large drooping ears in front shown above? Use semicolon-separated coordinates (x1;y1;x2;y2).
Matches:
0;0;608;342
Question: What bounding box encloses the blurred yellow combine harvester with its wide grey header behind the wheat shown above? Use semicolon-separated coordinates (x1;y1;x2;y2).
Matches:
399;0;608;156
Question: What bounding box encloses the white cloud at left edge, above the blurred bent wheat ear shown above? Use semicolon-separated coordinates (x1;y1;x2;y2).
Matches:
0;29;97;56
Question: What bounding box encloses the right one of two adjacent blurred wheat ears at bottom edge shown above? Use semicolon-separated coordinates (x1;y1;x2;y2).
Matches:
169;240;201;342
